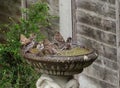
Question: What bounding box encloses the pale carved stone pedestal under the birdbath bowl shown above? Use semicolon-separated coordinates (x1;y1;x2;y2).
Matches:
36;74;79;88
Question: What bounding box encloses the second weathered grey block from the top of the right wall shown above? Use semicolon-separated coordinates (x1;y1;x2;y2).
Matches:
76;10;116;33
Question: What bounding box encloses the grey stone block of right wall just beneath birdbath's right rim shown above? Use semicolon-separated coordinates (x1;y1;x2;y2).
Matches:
83;64;118;85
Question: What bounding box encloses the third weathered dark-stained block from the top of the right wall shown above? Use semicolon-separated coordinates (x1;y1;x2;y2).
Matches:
77;23;116;46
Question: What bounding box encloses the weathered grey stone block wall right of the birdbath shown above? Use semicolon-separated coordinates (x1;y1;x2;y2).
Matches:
73;0;120;88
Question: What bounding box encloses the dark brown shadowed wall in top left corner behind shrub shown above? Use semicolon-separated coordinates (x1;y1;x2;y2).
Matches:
0;0;21;43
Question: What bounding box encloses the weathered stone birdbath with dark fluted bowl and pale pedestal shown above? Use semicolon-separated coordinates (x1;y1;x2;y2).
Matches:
23;44;98;88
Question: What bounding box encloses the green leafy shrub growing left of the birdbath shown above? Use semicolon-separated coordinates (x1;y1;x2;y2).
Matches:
0;2;51;88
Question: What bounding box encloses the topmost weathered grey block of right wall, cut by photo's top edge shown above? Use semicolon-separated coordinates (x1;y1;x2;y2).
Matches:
76;0;116;18
